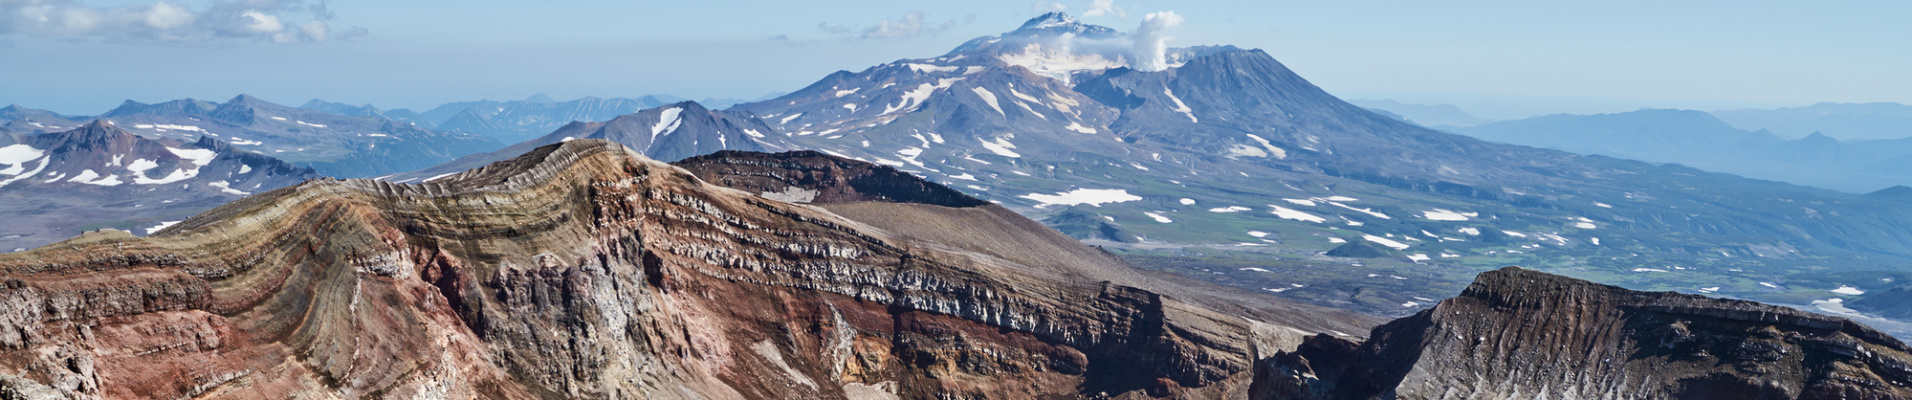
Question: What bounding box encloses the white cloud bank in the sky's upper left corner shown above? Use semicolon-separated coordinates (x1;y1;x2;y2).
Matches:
0;0;367;44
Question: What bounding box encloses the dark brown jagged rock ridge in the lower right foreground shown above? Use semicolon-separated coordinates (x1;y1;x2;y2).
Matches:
1252;268;1912;400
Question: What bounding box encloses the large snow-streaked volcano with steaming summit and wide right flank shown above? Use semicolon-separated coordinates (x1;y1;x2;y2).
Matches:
732;13;1912;310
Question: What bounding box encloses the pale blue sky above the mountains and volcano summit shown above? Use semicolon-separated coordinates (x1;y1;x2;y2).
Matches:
0;0;1912;119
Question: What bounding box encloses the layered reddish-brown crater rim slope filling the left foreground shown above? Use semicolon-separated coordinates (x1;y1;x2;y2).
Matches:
0;140;1373;398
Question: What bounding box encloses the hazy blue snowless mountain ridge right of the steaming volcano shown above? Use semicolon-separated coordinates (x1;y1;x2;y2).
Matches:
1455;109;1912;193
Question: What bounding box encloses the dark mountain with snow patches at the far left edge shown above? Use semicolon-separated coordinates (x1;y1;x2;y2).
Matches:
0;121;319;253
